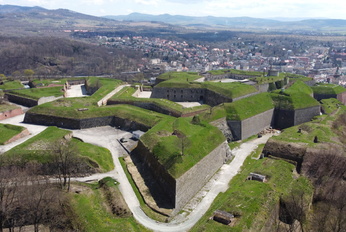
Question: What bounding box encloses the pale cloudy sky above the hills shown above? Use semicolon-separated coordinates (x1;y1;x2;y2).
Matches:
0;0;346;19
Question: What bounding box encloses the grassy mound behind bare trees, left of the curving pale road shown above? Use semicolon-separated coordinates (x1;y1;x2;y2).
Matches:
4;127;114;172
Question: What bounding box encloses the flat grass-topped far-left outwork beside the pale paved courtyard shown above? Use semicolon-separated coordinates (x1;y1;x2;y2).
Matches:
10;86;63;100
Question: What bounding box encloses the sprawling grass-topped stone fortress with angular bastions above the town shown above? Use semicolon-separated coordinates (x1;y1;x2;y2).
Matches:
15;71;346;213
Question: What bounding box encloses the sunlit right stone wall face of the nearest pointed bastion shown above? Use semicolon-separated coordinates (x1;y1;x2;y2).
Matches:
173;142;231;214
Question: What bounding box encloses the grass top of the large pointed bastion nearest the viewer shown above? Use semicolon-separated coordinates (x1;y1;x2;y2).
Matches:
141;118;225;178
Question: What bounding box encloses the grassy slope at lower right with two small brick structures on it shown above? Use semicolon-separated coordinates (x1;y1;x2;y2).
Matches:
191;153;313;232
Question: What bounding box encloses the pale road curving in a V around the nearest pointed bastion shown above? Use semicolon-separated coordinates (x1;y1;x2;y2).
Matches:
73;127;271;232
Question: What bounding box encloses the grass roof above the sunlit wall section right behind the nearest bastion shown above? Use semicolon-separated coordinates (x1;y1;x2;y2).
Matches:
225;93;274;120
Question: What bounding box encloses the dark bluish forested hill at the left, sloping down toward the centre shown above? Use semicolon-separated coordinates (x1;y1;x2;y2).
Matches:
0;5;171;37
